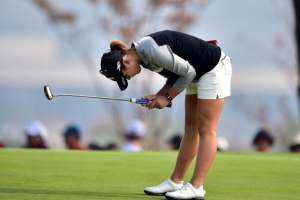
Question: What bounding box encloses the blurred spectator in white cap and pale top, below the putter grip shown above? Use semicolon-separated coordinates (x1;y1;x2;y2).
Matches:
122;119;146;151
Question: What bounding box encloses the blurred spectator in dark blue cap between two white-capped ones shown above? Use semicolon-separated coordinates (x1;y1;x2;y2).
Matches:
63;125;85;150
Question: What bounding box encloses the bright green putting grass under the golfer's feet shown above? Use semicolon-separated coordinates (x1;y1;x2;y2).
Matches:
0;149;300;200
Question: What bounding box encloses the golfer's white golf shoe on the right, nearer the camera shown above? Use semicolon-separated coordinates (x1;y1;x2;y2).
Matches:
165;183;206;200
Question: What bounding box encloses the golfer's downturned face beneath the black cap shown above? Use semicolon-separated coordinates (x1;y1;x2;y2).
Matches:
122;51;141;80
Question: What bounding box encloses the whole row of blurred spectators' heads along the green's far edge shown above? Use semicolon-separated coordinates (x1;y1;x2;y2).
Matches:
0;119;300;153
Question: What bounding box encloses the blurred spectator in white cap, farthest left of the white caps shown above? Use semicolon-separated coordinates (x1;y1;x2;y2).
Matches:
25;120;48;149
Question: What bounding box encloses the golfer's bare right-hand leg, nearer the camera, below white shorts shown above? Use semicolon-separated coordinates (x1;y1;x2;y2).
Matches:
190;99;224;188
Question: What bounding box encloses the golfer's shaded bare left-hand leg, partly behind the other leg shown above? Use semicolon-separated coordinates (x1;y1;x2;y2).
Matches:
171;94;199;182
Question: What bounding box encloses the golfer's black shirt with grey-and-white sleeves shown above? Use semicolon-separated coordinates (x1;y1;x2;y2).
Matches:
134;30;221;92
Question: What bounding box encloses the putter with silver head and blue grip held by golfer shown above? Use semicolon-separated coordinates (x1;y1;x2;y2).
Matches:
44;85;172;108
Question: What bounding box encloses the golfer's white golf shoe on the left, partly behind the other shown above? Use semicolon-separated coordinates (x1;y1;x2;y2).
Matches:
144;179;183;195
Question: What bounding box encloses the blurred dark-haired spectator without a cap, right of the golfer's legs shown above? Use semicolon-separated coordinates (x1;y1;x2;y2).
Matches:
252;129;274;152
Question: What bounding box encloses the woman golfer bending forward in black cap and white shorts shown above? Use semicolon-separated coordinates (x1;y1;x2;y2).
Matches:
100;30;232;199
